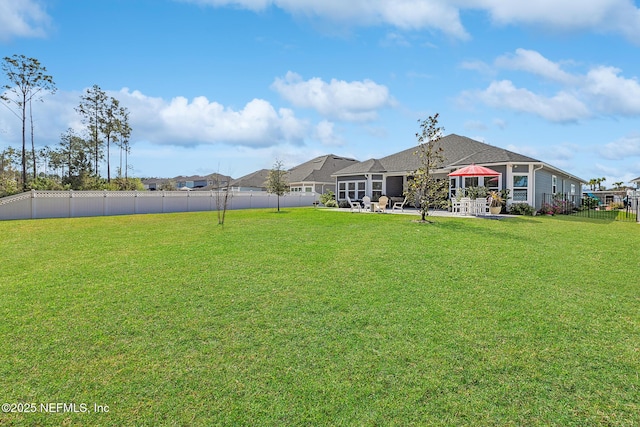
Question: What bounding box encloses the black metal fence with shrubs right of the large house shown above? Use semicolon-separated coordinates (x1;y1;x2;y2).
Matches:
538;192;640;222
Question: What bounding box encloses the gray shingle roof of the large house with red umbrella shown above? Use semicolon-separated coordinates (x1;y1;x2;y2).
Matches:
334;134;540;175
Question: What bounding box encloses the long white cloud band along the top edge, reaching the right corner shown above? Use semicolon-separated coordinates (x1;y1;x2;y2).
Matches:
181;0;640;44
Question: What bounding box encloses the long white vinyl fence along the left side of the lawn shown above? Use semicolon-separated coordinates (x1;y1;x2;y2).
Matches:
0;190;320;220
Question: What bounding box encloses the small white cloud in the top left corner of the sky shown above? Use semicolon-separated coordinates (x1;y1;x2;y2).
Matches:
0;0;50;41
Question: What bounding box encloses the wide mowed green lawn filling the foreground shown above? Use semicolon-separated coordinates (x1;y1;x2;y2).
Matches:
0;209;640;426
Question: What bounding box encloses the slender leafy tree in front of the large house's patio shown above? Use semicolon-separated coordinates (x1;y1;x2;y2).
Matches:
405;113;448;221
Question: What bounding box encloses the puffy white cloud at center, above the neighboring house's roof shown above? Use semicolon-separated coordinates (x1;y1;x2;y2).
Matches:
271;71;392;122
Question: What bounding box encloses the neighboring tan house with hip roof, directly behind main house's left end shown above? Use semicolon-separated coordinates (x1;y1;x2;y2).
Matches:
287;154;359;194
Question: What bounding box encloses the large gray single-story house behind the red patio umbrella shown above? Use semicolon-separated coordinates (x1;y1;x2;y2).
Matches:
333;134;584;209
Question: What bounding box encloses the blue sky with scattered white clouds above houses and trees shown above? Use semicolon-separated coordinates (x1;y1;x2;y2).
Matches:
0;0;640;186
